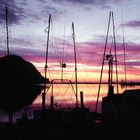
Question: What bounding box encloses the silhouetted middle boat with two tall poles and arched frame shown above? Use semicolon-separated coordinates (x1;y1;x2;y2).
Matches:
33;15;90;123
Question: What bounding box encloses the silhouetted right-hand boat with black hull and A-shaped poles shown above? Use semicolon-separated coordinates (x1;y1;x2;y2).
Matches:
96;12;140;125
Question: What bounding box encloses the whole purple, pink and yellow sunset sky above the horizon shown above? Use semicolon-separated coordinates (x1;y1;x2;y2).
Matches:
0;0;140;109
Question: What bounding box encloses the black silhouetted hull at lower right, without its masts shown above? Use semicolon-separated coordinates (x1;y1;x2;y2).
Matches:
102;89;140;123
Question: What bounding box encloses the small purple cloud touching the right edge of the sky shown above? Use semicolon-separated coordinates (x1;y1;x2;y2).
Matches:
124;20;140;28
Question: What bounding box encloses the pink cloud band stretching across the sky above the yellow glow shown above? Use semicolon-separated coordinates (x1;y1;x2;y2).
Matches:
0;39;140;83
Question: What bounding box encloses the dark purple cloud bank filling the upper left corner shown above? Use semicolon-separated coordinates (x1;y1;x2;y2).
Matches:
0;0;61;25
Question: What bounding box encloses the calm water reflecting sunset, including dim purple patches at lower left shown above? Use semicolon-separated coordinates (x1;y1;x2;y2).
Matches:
0;84;140;121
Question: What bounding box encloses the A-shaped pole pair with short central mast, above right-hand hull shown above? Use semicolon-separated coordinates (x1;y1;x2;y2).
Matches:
95;11;119;113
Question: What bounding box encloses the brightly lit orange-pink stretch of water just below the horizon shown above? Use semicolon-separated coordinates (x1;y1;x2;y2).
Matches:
34;84;140;112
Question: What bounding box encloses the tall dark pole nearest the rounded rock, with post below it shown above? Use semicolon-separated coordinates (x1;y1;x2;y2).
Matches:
42;15;51;110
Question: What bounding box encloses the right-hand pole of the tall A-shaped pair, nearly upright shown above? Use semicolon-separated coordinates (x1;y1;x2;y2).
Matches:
111;11;119;94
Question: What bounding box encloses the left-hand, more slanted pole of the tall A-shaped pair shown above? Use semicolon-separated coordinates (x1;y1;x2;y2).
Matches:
95;11;111;113
